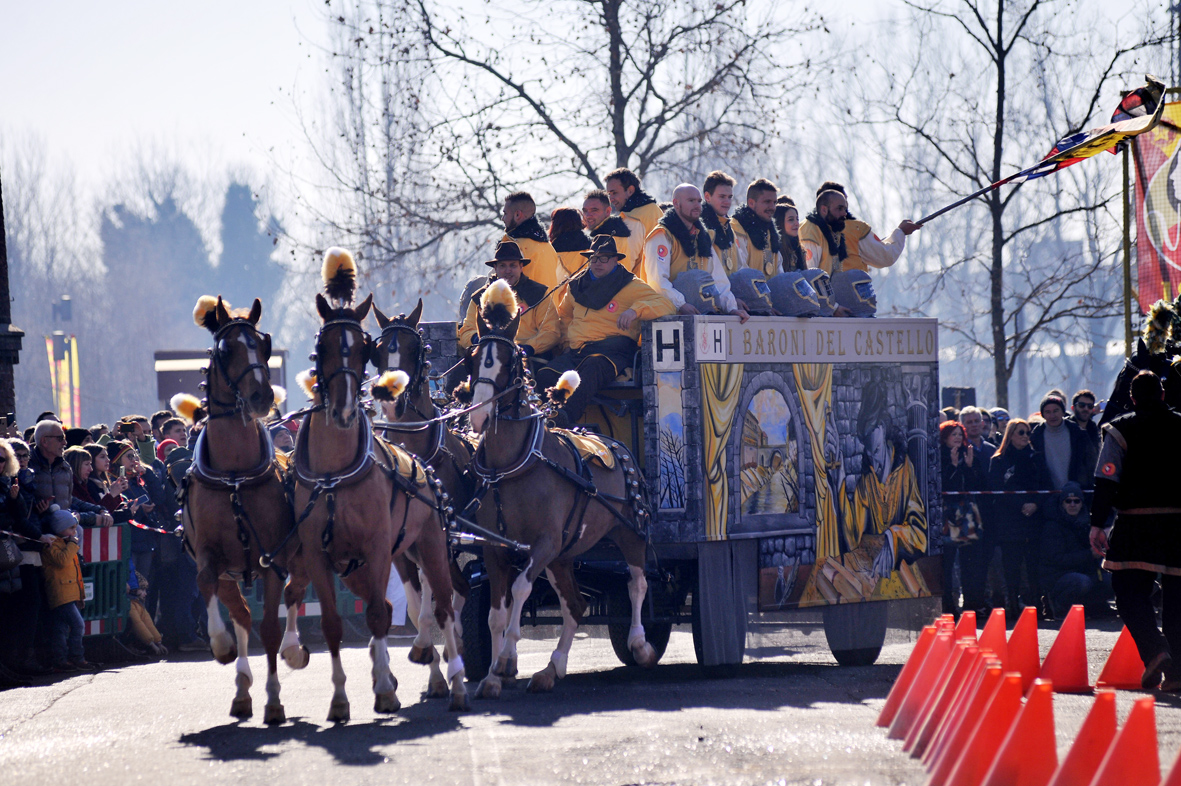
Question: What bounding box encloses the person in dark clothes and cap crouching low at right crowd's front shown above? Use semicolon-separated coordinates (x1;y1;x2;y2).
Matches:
1042;480;1111;616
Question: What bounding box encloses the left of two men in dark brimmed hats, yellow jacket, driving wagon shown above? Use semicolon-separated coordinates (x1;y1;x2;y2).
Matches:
459;241;561;359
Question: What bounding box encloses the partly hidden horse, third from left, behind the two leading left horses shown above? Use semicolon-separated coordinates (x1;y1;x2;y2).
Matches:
372;299;471;697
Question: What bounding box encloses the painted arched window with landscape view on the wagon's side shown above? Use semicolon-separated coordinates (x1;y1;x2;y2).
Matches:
739;388;800;515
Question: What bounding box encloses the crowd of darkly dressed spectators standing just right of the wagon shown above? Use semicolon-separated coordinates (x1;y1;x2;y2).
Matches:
939;389;1113;620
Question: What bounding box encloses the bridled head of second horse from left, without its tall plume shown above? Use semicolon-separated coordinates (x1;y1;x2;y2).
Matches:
313;293;373;428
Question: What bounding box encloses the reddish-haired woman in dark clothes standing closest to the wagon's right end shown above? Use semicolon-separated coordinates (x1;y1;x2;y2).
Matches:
939;420;987;617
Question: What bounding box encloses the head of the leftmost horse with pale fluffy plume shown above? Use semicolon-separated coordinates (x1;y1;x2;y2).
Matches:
193;295;275;418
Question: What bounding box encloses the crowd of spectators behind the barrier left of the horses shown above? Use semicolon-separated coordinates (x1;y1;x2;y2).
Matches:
0;410;208;688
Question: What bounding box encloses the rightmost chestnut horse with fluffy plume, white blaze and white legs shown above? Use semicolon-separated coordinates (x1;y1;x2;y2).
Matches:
461;290;657;699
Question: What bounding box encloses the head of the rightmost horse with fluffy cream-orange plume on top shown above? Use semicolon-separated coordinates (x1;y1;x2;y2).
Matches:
457;281;524;434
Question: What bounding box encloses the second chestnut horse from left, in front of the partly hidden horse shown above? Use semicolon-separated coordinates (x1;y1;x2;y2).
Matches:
294;294;468;721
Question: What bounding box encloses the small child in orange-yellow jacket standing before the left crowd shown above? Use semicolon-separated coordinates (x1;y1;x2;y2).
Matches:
41;517;94;673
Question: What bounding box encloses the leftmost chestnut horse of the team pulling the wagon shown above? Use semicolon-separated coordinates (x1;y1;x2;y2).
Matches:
183;296;308;723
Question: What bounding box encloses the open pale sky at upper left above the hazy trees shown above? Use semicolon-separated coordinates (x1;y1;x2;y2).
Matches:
0;0;325;184
